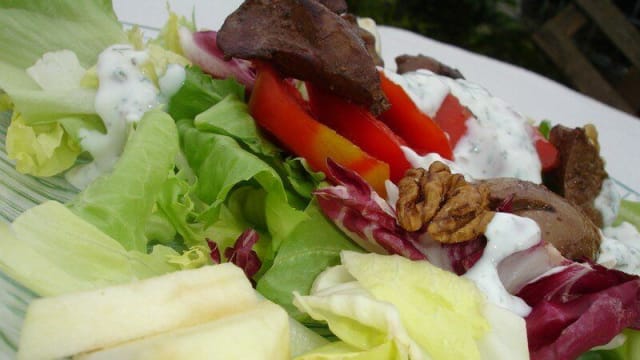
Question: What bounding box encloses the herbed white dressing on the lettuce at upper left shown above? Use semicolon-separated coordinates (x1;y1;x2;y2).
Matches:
66;45;185;189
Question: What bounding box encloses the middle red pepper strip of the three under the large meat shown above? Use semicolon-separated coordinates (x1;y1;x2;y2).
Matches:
307;83;411;182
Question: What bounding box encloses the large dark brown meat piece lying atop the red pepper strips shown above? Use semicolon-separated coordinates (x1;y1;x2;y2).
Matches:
217;0;388;115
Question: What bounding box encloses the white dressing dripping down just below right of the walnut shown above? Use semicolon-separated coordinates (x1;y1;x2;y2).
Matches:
463;213;541;317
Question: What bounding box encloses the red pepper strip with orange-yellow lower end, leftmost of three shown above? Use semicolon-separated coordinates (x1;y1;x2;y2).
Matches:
249;63;389;196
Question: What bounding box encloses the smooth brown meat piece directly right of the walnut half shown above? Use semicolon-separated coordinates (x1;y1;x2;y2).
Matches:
482;178;601;260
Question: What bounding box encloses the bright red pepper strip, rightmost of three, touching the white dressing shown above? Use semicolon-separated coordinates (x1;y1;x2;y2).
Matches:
379;71;453;160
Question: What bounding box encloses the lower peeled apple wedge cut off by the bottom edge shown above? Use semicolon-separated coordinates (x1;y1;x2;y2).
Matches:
77;300;289;360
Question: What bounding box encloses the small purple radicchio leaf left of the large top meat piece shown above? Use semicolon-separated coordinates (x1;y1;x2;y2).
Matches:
178;27;256;90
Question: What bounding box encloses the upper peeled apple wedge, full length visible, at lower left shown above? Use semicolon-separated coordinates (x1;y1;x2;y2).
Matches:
17;263;258;359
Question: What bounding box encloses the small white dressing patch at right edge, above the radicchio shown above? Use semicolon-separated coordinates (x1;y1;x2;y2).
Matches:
598;222;640;275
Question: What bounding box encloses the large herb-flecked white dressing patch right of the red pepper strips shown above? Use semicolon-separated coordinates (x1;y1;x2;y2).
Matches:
385;70;542;184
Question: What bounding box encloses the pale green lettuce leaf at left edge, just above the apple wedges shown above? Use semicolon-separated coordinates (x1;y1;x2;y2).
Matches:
0;201;178;296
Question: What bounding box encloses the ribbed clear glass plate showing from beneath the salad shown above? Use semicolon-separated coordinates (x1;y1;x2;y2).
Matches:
0;28;640;360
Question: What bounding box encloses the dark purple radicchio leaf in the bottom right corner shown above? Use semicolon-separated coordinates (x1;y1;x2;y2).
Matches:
518;263;640;360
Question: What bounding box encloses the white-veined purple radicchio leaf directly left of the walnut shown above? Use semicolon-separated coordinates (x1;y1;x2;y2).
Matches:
314;159;426;260
